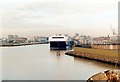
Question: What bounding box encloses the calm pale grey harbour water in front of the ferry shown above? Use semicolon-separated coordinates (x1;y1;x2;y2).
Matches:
2;44;114;80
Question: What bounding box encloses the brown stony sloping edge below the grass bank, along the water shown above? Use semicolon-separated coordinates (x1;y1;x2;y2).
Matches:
65;49;120;66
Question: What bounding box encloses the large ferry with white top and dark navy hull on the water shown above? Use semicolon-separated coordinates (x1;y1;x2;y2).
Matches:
49;34;72;50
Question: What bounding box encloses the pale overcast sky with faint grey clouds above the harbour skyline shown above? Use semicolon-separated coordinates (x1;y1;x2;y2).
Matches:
0;0;119;36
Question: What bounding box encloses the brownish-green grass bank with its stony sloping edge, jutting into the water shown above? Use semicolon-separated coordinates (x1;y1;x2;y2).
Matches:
65;47;120;65
